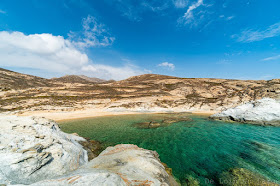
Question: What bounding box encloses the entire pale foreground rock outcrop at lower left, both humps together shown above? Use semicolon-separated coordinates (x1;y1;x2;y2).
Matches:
0;116;177;186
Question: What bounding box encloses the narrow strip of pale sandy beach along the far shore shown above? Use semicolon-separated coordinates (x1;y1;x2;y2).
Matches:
12;109;216;122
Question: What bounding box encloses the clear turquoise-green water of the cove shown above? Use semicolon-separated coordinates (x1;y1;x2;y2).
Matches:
60;114;280;185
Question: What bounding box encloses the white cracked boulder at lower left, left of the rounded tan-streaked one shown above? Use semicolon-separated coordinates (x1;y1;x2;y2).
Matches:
0;116;88;184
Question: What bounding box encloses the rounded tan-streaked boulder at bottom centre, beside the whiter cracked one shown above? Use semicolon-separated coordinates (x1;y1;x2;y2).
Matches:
26;144;177;186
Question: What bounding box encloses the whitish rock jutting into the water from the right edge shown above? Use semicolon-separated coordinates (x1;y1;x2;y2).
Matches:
210;98;280;126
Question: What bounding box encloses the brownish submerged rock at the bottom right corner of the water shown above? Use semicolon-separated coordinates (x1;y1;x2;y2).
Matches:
219;168;278;186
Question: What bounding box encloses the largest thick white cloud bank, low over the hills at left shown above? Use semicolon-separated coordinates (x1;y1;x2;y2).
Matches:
0;31;145;80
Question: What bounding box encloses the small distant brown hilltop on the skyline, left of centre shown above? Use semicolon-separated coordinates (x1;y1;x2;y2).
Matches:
51;75;106;83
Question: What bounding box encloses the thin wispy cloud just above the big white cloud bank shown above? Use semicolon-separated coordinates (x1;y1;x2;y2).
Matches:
69;15;115;48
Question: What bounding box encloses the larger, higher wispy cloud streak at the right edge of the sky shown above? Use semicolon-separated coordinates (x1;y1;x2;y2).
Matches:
232;22;280;43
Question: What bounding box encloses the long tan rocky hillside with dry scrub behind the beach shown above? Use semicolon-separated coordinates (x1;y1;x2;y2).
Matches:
0;67;280;112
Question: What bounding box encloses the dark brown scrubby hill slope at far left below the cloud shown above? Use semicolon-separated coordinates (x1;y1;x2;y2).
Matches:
0;68;52;90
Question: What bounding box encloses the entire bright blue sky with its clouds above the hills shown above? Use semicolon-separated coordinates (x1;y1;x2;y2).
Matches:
0;0;280;79
